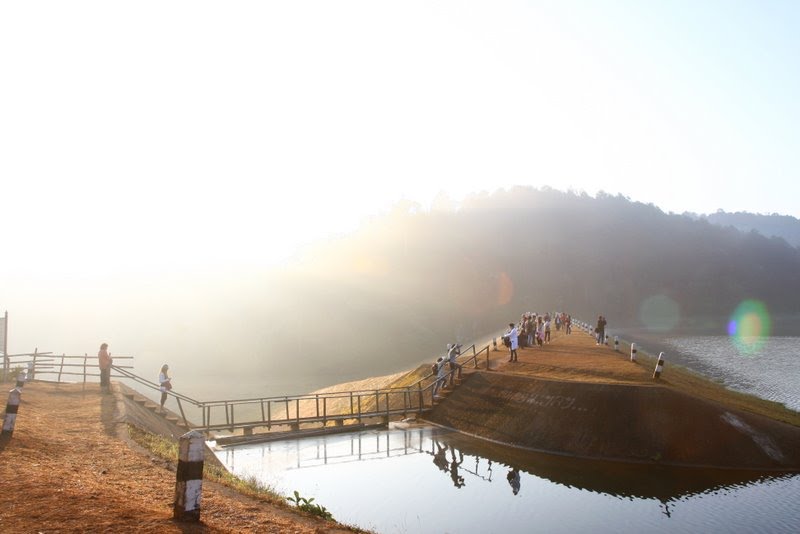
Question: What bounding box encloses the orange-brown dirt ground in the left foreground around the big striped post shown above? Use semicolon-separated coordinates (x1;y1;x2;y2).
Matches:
0;382;356;533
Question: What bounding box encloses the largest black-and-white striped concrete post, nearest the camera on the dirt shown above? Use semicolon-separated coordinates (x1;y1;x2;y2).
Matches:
173;430;205;521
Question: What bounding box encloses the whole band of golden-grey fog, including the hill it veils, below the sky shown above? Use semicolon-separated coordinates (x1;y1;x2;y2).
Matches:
6;188;800;400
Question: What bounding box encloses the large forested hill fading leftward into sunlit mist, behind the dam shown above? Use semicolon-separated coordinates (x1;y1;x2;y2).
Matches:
247;188;800;376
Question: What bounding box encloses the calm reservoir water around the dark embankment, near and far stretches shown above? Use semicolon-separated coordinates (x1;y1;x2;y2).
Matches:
218;336;800;533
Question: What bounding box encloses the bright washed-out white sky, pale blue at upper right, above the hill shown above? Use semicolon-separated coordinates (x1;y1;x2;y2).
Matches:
0;0;800;276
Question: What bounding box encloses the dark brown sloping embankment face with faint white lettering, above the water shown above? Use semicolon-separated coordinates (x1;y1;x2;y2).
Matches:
426;372;800;470
